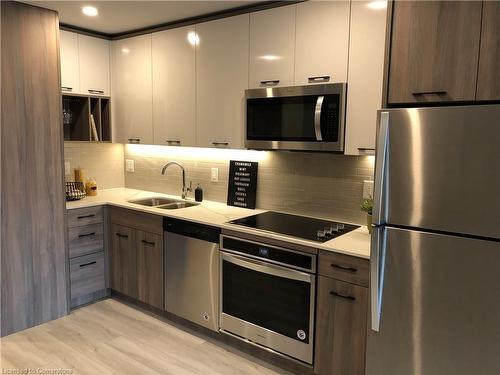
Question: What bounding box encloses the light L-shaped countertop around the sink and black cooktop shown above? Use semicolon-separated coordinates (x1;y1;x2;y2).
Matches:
66;188;370;259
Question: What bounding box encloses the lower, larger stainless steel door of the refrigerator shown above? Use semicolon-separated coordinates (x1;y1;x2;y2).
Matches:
366;228;500;375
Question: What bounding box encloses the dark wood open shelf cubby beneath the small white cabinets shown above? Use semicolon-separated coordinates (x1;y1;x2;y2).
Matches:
62;94;111;142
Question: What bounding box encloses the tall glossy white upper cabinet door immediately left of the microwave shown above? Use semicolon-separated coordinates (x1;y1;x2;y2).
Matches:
196;14;249;148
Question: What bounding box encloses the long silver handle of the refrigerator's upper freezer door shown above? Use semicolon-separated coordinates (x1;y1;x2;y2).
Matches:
373;112;389;225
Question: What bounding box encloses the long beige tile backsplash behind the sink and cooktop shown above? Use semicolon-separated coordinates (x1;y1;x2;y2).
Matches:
124;145;373;224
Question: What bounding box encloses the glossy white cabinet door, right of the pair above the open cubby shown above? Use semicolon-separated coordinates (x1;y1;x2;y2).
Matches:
78;35;110;96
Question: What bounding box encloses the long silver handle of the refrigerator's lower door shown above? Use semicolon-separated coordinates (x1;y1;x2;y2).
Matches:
370;227;387;332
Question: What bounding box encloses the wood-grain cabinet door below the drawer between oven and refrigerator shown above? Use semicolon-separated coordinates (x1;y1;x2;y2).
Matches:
314;276;368;375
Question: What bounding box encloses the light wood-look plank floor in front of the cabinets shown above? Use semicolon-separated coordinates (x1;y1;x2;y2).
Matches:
0;299;286;375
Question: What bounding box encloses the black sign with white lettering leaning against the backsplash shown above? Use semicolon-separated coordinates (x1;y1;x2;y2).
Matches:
227;160;259;208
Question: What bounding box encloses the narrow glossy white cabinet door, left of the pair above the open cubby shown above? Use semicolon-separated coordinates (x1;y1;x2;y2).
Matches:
60;30;80;93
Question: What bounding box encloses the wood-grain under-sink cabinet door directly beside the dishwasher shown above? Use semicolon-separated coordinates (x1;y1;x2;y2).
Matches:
136;231;164;309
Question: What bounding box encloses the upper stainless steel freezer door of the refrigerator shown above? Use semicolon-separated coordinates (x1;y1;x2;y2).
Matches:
374;104;500;238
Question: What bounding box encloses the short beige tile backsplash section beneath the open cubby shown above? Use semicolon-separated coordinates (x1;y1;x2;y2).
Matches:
64;142;125;189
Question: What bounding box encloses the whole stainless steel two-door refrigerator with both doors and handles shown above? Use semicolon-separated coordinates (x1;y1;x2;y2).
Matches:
366;104;500;375
